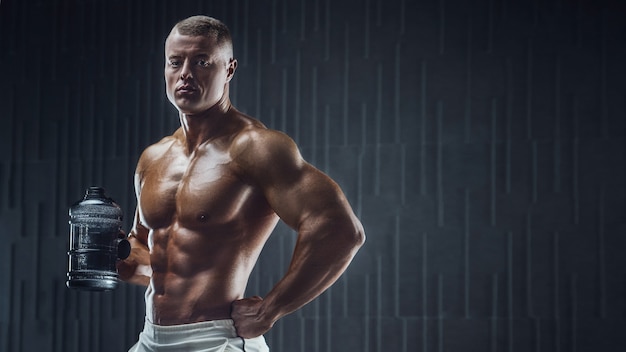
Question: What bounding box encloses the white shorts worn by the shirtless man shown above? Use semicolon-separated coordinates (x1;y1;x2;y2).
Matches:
128;319;269;352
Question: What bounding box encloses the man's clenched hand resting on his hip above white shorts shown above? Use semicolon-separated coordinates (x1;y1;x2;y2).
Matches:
230;296;274;339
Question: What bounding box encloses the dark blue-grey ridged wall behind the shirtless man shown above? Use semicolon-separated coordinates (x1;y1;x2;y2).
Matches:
0;0;626;352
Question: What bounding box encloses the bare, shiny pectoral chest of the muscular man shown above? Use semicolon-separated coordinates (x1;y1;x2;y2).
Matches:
139;148;261;229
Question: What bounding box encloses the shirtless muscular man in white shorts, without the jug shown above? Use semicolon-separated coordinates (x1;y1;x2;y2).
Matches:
118;16;365;351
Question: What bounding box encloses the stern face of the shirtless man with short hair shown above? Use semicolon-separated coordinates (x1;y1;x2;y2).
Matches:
165;31;237;115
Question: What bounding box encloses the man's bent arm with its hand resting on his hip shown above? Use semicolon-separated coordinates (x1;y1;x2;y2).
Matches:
232;131;365;338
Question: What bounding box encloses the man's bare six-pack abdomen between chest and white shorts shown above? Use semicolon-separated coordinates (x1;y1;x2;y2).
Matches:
145;221;275;325
